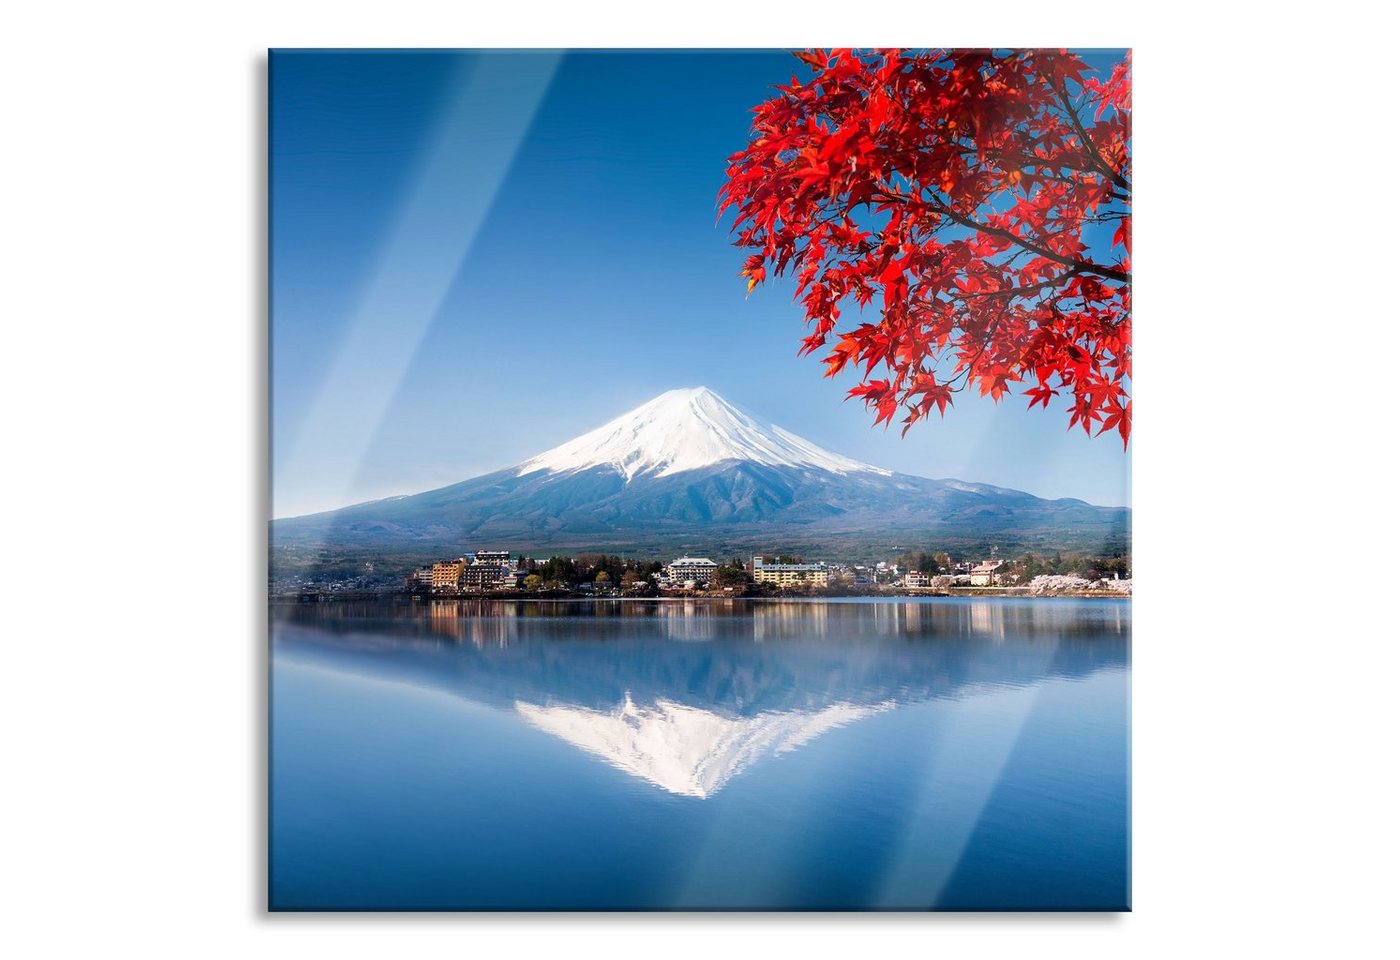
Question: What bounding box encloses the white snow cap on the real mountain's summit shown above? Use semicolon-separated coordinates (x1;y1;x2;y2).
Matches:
518;386;890;481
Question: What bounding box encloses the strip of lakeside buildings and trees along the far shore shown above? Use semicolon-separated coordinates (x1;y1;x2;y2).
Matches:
273;550;1133;599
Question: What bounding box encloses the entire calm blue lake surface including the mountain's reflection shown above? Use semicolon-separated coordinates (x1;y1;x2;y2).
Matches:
269;599;1131;910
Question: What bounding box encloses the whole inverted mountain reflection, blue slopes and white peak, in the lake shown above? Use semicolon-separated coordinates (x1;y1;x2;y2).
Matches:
273;600;1130;798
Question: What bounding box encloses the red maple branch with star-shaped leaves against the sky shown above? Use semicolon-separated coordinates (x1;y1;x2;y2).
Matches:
720;50;1133;448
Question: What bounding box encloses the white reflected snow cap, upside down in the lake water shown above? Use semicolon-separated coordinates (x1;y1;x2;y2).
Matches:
515;696;893;798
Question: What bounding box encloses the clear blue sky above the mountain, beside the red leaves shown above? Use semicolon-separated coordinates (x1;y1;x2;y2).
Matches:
270;50;1130;516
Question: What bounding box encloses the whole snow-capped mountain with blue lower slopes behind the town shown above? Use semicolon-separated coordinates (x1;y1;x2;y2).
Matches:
272;386;1128;556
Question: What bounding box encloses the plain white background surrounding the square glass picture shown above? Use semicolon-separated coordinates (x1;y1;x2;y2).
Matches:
0;0;1400;960
